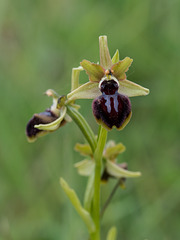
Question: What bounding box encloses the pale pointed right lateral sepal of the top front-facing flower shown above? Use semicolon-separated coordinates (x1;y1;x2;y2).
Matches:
118;80;149;97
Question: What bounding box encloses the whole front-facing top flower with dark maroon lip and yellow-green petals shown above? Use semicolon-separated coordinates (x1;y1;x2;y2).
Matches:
67;36;149;130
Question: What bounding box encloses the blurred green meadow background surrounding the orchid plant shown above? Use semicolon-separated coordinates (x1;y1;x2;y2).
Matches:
0;0;180;240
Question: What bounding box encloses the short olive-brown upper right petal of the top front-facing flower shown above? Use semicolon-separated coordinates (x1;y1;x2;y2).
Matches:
111;57;133;81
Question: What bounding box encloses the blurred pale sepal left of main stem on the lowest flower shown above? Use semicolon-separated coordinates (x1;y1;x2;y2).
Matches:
74;159;95;176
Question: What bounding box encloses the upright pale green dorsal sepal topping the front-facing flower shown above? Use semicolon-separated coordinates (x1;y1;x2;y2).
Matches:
99;36;112;69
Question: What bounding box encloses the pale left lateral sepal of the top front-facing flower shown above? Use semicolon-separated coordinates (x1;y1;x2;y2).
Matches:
67;82;102;101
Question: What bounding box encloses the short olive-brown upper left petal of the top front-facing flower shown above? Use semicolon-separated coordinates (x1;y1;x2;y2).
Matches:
80;60;105;82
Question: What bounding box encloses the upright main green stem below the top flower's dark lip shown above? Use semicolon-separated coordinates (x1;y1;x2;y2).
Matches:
91;126;107;240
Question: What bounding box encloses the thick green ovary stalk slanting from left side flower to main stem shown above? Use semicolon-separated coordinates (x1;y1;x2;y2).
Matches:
66;105;97;153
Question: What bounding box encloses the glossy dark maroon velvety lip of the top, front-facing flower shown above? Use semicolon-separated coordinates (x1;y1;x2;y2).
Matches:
92;80;131;130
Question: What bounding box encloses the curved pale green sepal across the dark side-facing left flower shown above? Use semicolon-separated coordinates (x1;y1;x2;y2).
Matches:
34;107;66;131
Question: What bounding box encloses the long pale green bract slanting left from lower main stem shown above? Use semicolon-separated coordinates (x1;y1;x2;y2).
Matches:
60;178;95;234
